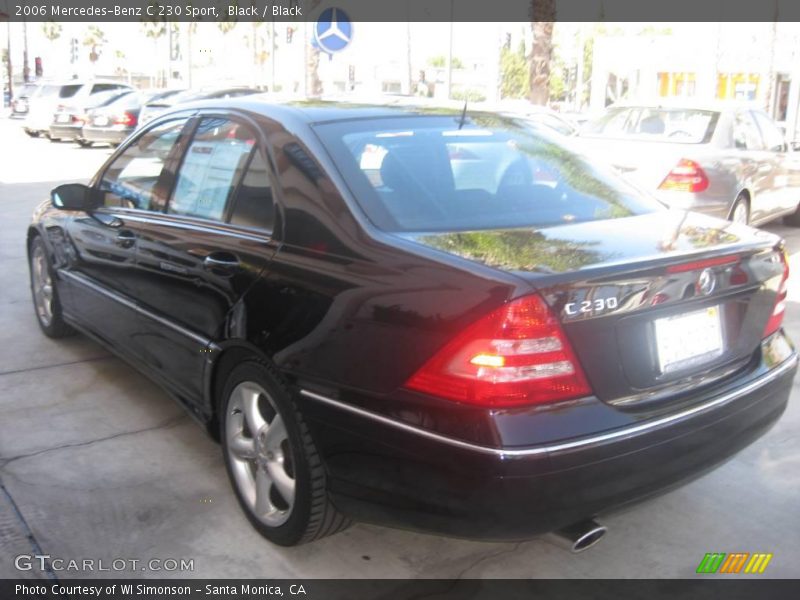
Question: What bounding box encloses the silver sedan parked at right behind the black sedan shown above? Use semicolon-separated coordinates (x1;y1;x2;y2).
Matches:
576;105;800;226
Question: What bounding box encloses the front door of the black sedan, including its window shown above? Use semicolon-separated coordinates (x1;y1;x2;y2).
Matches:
64;118;188;358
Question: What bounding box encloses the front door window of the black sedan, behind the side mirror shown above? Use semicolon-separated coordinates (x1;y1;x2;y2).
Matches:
100;119;186;212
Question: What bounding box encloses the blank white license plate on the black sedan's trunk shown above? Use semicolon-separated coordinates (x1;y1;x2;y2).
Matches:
655;306;723;373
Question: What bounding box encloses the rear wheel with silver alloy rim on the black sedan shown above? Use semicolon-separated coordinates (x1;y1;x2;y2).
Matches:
220;361;350;546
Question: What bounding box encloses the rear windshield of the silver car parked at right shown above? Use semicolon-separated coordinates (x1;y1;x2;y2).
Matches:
581;107;719;144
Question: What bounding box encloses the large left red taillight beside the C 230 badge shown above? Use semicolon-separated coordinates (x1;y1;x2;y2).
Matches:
405;295;592;407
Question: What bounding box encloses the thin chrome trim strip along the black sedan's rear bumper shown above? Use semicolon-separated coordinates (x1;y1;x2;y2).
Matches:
300;352;798;459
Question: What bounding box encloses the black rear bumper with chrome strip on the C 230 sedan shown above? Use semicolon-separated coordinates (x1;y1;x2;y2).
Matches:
304;332;797;540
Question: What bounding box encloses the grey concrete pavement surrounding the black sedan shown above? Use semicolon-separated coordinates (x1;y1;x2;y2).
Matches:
0;113;800;579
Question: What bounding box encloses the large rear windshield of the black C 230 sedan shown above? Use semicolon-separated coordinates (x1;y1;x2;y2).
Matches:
316;116;663;232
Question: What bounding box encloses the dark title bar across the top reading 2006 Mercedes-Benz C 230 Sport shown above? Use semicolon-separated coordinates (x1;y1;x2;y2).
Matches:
0;0;800;22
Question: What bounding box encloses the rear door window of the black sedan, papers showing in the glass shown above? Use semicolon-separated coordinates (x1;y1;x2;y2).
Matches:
167;118;256;220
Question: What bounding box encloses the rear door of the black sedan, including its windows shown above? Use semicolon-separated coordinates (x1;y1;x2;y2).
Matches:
128;114;277;400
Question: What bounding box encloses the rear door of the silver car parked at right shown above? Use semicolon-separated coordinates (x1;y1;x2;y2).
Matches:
730;110;776;223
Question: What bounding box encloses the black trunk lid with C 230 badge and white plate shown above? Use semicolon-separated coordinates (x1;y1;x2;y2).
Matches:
396;211;783;405
